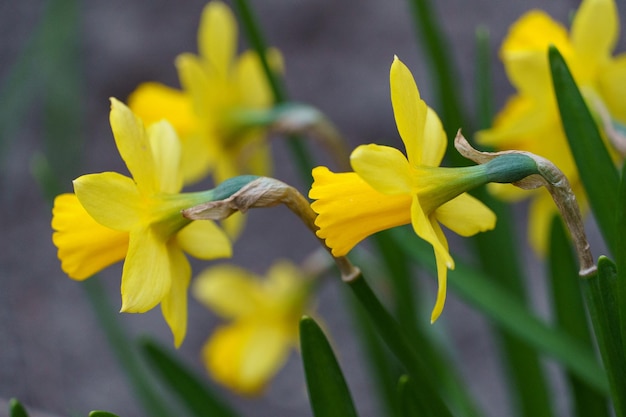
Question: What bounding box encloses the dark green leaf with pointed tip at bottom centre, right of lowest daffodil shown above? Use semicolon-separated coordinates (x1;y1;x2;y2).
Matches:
300;316;357;417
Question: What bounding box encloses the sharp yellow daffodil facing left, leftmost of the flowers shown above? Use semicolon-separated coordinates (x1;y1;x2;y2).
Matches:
52;99;231;346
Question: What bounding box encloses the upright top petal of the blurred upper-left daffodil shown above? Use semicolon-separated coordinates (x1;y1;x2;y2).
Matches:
198;1;237;77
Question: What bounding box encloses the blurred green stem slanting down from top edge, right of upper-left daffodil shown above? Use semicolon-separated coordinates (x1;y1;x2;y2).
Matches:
234;0;314;180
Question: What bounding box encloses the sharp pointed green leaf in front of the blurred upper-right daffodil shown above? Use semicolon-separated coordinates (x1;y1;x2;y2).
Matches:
548;46;623;254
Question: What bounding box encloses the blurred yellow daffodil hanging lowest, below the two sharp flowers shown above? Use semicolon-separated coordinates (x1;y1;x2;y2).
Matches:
192;261;310;395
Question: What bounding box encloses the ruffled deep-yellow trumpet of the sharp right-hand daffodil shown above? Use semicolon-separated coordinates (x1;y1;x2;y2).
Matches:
309;167;411;256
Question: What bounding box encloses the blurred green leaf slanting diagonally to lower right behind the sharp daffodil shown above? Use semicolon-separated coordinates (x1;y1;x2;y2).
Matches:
394;229;608;393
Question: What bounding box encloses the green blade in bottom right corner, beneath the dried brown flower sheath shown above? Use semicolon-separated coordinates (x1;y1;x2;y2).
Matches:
582;256;626;417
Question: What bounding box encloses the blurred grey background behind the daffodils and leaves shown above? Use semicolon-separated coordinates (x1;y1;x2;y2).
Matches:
0;0;625;417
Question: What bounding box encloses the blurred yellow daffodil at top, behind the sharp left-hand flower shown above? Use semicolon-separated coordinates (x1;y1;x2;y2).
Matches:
129;1;281;184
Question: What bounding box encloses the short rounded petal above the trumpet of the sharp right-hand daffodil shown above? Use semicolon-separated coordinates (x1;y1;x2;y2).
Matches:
350;144;413;194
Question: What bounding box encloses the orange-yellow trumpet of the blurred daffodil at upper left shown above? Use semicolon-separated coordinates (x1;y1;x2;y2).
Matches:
128;82;198;137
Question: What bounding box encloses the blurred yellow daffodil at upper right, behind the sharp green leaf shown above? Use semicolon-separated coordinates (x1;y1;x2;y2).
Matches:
477;0;626;253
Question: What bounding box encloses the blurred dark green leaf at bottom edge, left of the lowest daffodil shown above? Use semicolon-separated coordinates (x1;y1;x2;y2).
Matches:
140;339;237;417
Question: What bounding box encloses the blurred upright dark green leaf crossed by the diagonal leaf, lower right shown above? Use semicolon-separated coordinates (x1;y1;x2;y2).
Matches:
547;217;608;417
